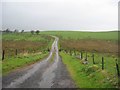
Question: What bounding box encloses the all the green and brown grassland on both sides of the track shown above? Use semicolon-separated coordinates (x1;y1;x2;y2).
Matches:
2;31;120;88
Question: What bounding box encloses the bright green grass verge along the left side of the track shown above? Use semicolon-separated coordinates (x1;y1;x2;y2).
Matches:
2;53;48;75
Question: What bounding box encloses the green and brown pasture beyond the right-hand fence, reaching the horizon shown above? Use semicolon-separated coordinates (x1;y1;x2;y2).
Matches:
42;31;119;56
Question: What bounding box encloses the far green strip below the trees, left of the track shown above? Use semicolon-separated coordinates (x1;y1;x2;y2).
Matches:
2;33;49;42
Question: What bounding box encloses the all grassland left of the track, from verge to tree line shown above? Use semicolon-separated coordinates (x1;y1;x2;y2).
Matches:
2;33;54;75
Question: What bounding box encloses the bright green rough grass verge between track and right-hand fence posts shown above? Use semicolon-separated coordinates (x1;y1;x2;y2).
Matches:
60;52;118;88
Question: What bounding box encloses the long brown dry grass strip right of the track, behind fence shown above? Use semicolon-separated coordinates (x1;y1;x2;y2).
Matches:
60;40;118;54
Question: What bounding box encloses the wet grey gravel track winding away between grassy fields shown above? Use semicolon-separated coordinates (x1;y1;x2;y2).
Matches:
2;36;75;88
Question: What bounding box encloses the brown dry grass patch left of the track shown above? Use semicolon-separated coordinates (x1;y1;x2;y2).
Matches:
2;41;48;55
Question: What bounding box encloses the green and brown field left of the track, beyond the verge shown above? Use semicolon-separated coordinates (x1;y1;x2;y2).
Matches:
2;33;54;56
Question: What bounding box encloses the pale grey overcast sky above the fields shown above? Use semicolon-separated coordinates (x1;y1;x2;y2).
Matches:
0;0;119;31
